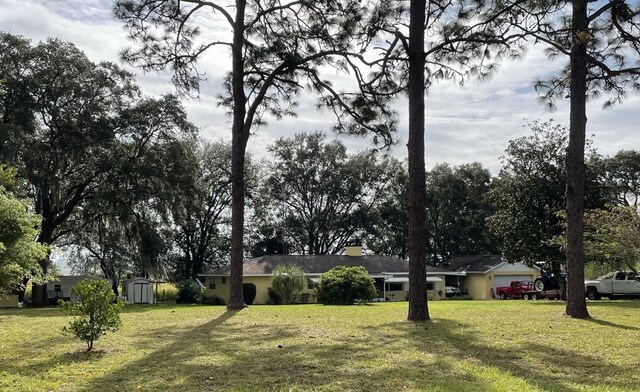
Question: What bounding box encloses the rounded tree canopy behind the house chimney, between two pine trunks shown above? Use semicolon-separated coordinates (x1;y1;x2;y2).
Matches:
259;132;400;254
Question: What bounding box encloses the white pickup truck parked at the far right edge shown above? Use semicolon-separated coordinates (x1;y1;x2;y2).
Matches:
584;271;640;299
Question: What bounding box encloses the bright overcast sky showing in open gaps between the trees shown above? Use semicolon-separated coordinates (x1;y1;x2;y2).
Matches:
0;0;640;174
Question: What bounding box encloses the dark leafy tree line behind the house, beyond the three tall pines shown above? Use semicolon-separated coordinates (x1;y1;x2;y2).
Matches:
0;13;637;310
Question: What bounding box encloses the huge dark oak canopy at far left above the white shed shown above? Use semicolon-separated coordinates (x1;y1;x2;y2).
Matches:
0;34;195;304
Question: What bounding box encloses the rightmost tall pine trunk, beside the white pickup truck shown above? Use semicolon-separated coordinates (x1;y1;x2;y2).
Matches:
566;0;589;318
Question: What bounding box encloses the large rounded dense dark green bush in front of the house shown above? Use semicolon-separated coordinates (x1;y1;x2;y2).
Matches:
315;266;377;305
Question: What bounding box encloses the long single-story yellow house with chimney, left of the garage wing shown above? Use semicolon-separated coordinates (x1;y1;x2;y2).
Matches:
199;246;464;304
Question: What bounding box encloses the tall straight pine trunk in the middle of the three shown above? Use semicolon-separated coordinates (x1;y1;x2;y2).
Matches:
407;0;429;321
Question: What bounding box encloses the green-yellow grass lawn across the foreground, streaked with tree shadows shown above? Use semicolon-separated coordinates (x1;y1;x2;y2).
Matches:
0;300;640;392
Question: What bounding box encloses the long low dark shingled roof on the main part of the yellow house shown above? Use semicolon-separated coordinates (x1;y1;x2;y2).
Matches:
200;255;451;276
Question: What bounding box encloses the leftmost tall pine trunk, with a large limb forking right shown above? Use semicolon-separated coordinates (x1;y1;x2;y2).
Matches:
227;0;251;310
